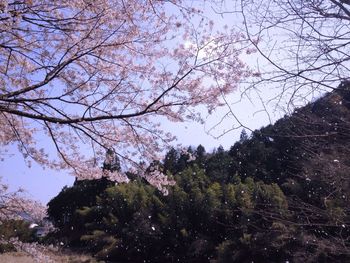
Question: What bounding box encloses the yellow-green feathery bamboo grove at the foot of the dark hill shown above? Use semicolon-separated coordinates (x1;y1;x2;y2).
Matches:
48;163;292;262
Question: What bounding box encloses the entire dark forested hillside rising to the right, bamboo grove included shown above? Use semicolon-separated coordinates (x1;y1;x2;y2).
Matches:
49;84;350;262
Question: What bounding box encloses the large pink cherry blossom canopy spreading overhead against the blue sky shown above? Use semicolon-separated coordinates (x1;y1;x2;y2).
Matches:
0;0;251;190
